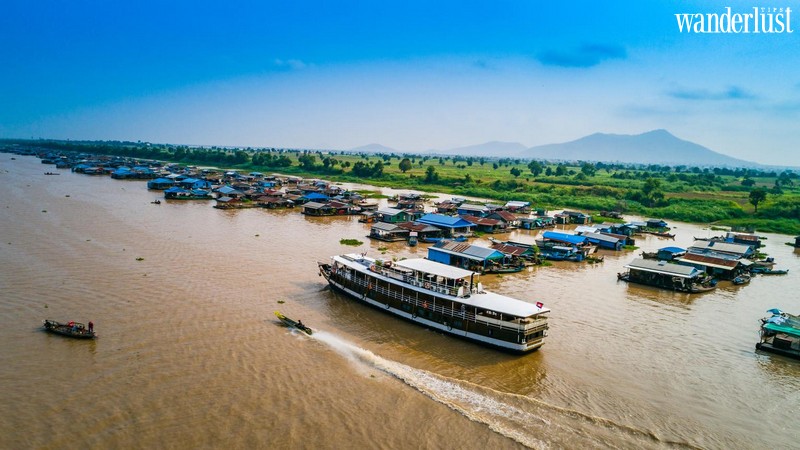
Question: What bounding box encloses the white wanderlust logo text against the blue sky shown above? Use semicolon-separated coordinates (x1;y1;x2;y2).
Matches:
675;6;794;34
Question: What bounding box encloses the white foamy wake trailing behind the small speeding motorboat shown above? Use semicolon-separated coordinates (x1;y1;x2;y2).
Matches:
312;331;696;449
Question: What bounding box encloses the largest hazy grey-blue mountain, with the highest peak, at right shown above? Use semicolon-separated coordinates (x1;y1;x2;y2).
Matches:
518;130;758;167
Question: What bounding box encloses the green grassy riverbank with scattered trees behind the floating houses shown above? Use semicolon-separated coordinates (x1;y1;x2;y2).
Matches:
3;141;800;235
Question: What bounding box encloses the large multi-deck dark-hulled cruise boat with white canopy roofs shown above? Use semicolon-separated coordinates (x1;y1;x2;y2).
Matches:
318;254;550;353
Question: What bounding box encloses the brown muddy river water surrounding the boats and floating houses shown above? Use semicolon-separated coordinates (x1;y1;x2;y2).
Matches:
0;154;800;449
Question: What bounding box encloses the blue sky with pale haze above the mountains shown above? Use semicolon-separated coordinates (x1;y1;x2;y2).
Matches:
0;0;800;166
